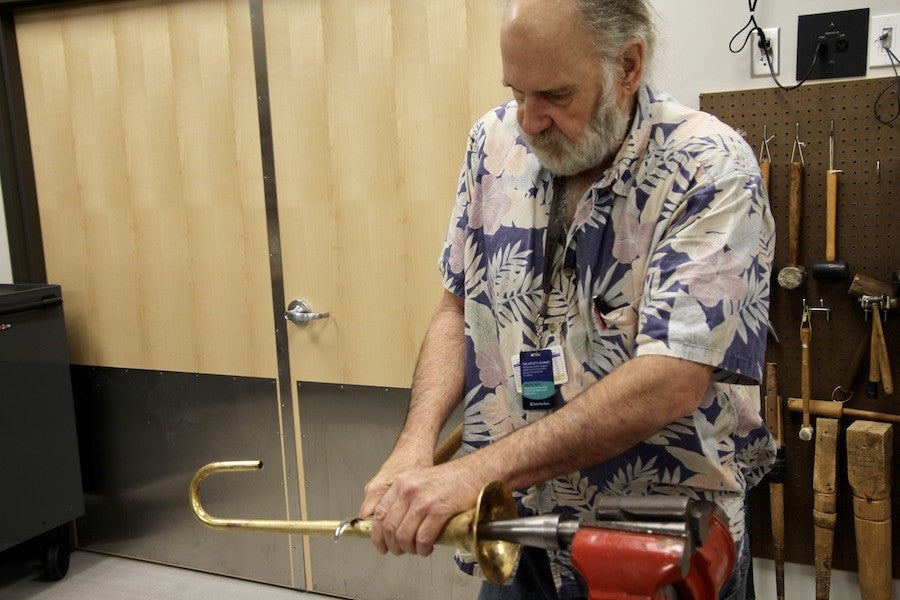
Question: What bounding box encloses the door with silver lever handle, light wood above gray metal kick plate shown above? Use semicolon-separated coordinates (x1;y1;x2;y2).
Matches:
264;0;507;599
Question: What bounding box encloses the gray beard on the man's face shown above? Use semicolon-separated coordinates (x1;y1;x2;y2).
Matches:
519;94;630;177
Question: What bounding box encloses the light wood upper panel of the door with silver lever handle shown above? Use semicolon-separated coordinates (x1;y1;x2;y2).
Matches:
264;0;507;387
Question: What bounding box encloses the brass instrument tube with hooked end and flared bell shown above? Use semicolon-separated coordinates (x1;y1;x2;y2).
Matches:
190;460;519;584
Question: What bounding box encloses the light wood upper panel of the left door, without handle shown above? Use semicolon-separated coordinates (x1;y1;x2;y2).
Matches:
16;0;277;377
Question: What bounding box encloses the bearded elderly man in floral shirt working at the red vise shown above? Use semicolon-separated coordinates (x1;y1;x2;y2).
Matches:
360;0;774;598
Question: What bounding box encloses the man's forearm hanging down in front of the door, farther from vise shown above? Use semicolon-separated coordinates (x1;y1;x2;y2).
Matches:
397;291;466;452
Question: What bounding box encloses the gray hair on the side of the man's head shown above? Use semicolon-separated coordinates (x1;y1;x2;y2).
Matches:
575;0;656;64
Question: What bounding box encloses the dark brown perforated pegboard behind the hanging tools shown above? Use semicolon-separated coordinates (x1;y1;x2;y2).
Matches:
700;78;900;576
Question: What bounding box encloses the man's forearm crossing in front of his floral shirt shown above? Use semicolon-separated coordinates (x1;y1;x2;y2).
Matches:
461;356;711;488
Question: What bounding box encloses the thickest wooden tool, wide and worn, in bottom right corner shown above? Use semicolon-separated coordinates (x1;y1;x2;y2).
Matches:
847;421;894;600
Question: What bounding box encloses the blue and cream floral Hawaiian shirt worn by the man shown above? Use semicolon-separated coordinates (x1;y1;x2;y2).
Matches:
440;87;775;598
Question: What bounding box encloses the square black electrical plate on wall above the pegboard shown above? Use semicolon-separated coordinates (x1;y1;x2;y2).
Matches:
797;8;869;81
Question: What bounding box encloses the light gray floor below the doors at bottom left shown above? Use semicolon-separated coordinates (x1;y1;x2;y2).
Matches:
0;550;329;600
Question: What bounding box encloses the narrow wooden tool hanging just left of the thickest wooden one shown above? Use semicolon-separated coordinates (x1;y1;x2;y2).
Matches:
813;417;840;600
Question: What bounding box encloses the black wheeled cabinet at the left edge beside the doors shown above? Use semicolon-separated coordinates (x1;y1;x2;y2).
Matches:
0;284;84;578
